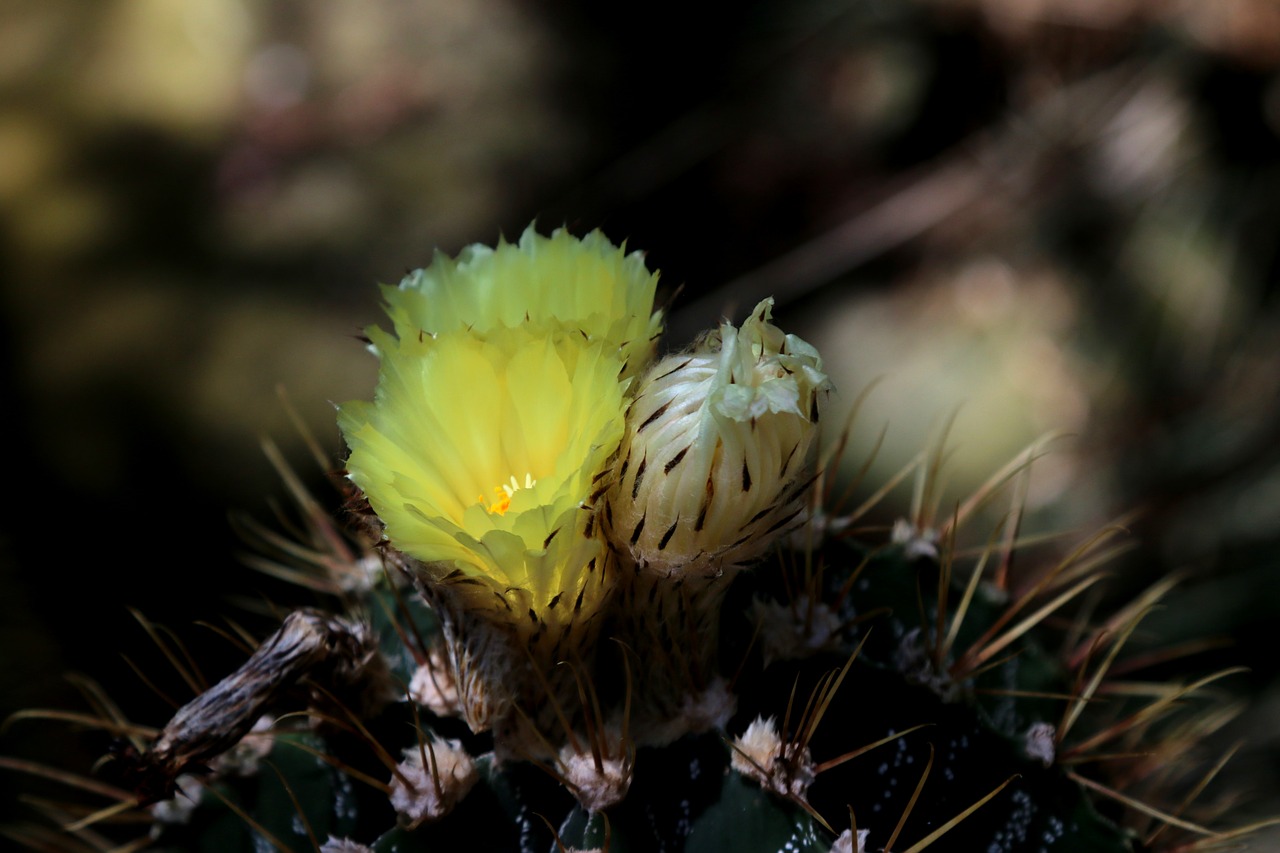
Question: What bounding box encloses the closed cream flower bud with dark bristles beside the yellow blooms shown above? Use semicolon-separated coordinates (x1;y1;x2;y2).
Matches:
605;300;829;578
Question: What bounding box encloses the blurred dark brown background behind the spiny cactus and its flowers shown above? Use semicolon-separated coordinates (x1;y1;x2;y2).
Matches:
0;0;1280;835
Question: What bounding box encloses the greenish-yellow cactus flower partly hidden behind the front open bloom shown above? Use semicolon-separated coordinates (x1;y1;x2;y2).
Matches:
383;225;662;378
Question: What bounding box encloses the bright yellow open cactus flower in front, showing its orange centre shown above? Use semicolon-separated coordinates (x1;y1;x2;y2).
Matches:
339;328;623;613
